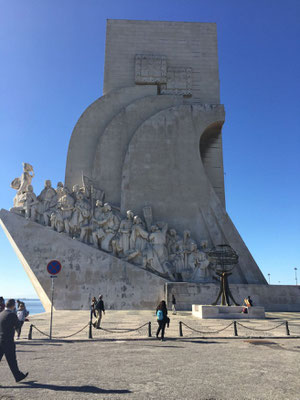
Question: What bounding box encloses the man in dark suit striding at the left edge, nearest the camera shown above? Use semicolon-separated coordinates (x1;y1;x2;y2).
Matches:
0;299;28;382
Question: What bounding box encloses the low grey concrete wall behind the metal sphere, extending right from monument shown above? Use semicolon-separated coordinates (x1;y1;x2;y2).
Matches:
166;278;300;312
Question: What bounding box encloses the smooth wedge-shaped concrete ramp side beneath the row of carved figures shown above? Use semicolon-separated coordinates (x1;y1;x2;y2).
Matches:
0;210;165;310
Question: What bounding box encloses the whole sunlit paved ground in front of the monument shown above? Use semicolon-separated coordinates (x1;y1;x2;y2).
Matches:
0;310;300;400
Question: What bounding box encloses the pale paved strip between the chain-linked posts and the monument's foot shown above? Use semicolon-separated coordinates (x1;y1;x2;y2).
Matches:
22;310;300;340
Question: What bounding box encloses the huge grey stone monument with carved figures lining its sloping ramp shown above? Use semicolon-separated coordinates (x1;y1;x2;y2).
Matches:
1;20;300;309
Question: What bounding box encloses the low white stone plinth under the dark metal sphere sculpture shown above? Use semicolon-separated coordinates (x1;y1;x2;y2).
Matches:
192;304;265;319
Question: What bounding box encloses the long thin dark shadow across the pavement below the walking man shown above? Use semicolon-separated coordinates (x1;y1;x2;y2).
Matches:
1;381;132;394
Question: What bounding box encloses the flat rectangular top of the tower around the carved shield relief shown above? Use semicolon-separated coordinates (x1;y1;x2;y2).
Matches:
103;19;220;104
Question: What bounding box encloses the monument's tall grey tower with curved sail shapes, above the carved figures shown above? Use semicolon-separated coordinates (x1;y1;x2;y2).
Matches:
66;20;266;283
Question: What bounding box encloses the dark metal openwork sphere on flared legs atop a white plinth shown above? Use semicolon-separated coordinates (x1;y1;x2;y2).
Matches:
207;244;239;306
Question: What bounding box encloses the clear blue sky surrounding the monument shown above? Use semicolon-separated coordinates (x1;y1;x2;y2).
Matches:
0;0;300;297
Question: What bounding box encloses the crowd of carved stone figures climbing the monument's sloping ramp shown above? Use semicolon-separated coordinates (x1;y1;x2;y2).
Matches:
11;163;212;282
